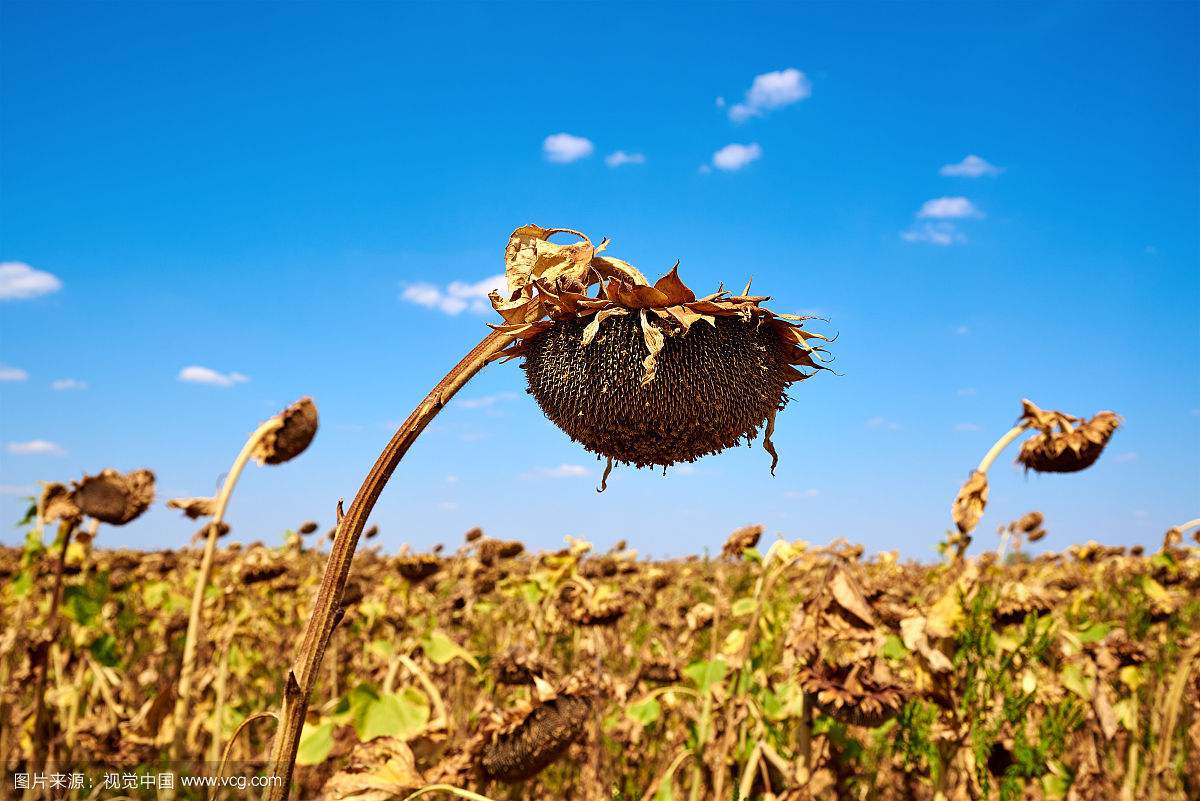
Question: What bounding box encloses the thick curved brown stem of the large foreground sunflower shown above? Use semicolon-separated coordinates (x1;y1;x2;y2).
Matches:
263;331;512;801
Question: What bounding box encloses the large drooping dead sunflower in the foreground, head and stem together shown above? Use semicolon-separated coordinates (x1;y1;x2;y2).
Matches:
266;225;827;801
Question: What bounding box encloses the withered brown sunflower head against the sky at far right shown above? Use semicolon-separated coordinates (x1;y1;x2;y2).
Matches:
1016;401;1121;472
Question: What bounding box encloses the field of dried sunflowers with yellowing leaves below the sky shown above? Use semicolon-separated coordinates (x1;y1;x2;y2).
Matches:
0;525;1200;801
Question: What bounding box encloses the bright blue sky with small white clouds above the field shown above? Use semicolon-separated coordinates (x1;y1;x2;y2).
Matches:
0;1;1200;558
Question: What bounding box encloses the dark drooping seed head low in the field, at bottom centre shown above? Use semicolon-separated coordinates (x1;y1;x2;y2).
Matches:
480;695;592;782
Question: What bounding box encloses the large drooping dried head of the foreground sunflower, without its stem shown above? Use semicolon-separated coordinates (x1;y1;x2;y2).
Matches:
482;225;826;469
